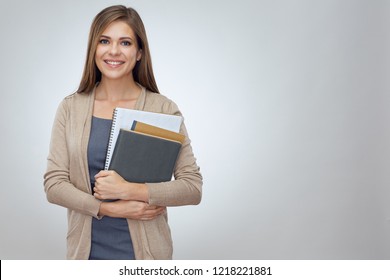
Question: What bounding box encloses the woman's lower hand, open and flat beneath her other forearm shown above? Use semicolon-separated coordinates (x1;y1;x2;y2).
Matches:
99;200;166;221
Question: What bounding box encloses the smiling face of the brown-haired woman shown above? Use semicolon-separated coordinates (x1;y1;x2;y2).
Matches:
95;21;141;80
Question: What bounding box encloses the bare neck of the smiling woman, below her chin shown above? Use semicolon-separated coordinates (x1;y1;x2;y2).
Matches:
96;77;141;101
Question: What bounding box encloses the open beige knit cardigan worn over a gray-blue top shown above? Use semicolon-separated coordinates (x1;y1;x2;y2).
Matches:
44;88;202;259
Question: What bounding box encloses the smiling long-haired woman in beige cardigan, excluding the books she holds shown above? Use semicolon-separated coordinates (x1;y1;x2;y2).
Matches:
44;6;202;259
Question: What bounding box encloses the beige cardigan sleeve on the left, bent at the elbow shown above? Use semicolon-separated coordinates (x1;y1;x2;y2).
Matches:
44;99;101;218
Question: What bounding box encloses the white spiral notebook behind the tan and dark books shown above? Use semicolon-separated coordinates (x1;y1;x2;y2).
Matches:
104;108;183;170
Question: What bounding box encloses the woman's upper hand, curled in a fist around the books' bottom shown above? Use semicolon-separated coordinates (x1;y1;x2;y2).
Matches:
93;170;149;201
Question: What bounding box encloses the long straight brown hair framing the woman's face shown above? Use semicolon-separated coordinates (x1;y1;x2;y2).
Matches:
77;5;159;93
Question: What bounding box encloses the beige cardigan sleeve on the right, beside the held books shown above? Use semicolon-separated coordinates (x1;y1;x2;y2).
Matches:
147;101;203;206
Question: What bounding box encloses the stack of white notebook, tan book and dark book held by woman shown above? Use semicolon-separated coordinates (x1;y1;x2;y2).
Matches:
105;108;185;183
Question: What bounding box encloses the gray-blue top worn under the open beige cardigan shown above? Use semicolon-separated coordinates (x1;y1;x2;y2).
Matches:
87;117;135;260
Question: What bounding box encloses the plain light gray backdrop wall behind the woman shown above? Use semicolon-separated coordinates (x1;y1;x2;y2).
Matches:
0;0;390;259
